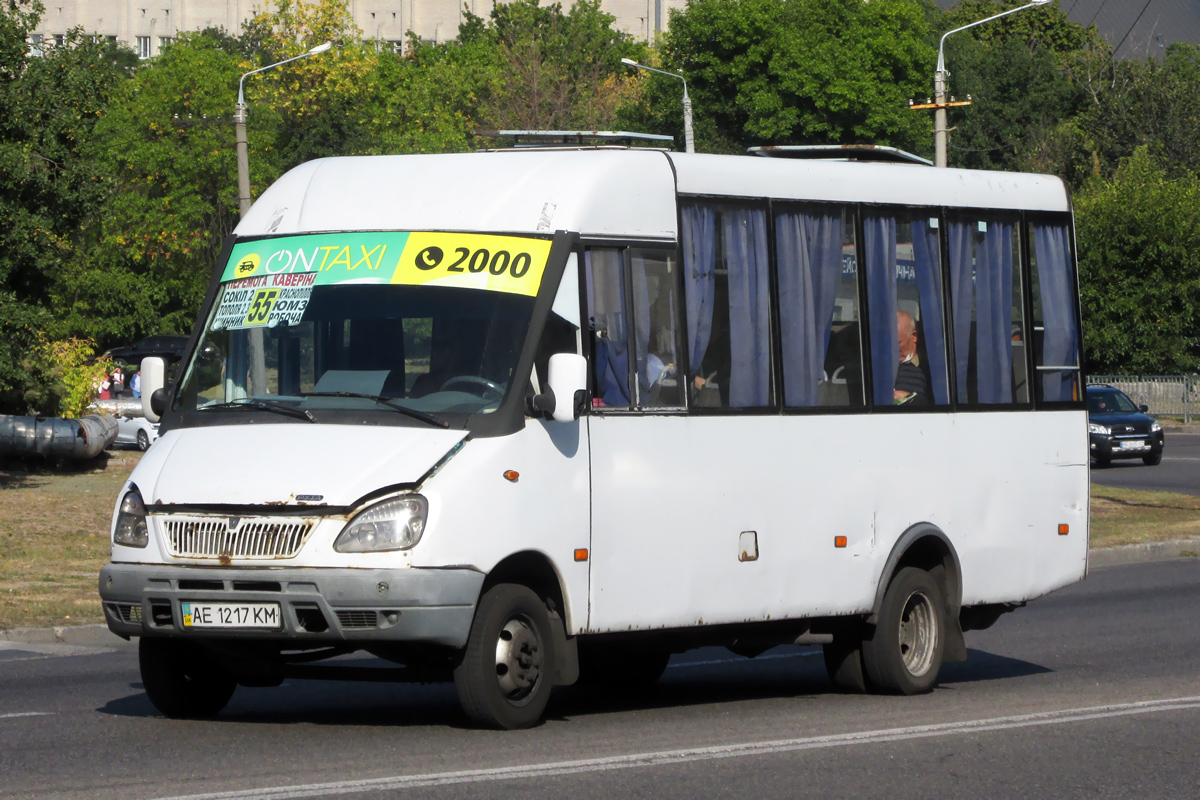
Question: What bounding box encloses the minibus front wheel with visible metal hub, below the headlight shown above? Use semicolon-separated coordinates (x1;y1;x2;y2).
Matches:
454;583;554;730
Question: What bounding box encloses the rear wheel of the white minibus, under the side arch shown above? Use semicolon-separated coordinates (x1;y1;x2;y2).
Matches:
863;566;946;694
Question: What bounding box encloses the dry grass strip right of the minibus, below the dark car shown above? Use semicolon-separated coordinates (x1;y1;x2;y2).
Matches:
1092;483;1200;547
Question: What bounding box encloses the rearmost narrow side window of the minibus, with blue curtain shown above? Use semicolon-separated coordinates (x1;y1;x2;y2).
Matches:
1028;219;1081;403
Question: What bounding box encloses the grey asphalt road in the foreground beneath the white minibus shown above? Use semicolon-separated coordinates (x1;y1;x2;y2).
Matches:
0;559;1200;800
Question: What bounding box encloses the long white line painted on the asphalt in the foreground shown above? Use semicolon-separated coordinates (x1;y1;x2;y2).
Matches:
147;697;1200;800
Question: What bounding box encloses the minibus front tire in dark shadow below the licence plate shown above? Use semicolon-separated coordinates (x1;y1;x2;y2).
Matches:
138;636;238;718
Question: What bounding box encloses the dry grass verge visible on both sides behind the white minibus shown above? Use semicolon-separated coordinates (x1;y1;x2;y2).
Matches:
0;451;1200;630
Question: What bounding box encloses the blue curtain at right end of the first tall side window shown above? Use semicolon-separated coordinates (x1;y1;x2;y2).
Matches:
721;207;770;408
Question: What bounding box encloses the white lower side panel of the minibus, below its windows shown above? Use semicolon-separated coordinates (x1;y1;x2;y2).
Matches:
589;413;1087;632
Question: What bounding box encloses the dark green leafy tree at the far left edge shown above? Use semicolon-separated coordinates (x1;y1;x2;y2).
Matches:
0;6;137;413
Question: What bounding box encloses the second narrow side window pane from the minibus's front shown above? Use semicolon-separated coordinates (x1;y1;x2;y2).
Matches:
630;248;683;408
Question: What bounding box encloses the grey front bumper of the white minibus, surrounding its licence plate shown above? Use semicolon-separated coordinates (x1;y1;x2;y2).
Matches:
100;564;484;648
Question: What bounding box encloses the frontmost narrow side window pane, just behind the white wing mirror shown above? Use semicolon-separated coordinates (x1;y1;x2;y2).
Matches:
583;248;632;408
